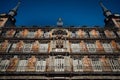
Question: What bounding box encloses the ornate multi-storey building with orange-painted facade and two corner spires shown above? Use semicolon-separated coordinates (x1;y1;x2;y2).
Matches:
0;2;120;80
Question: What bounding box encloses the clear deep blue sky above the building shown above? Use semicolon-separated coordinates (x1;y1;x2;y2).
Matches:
0;0;120;27
